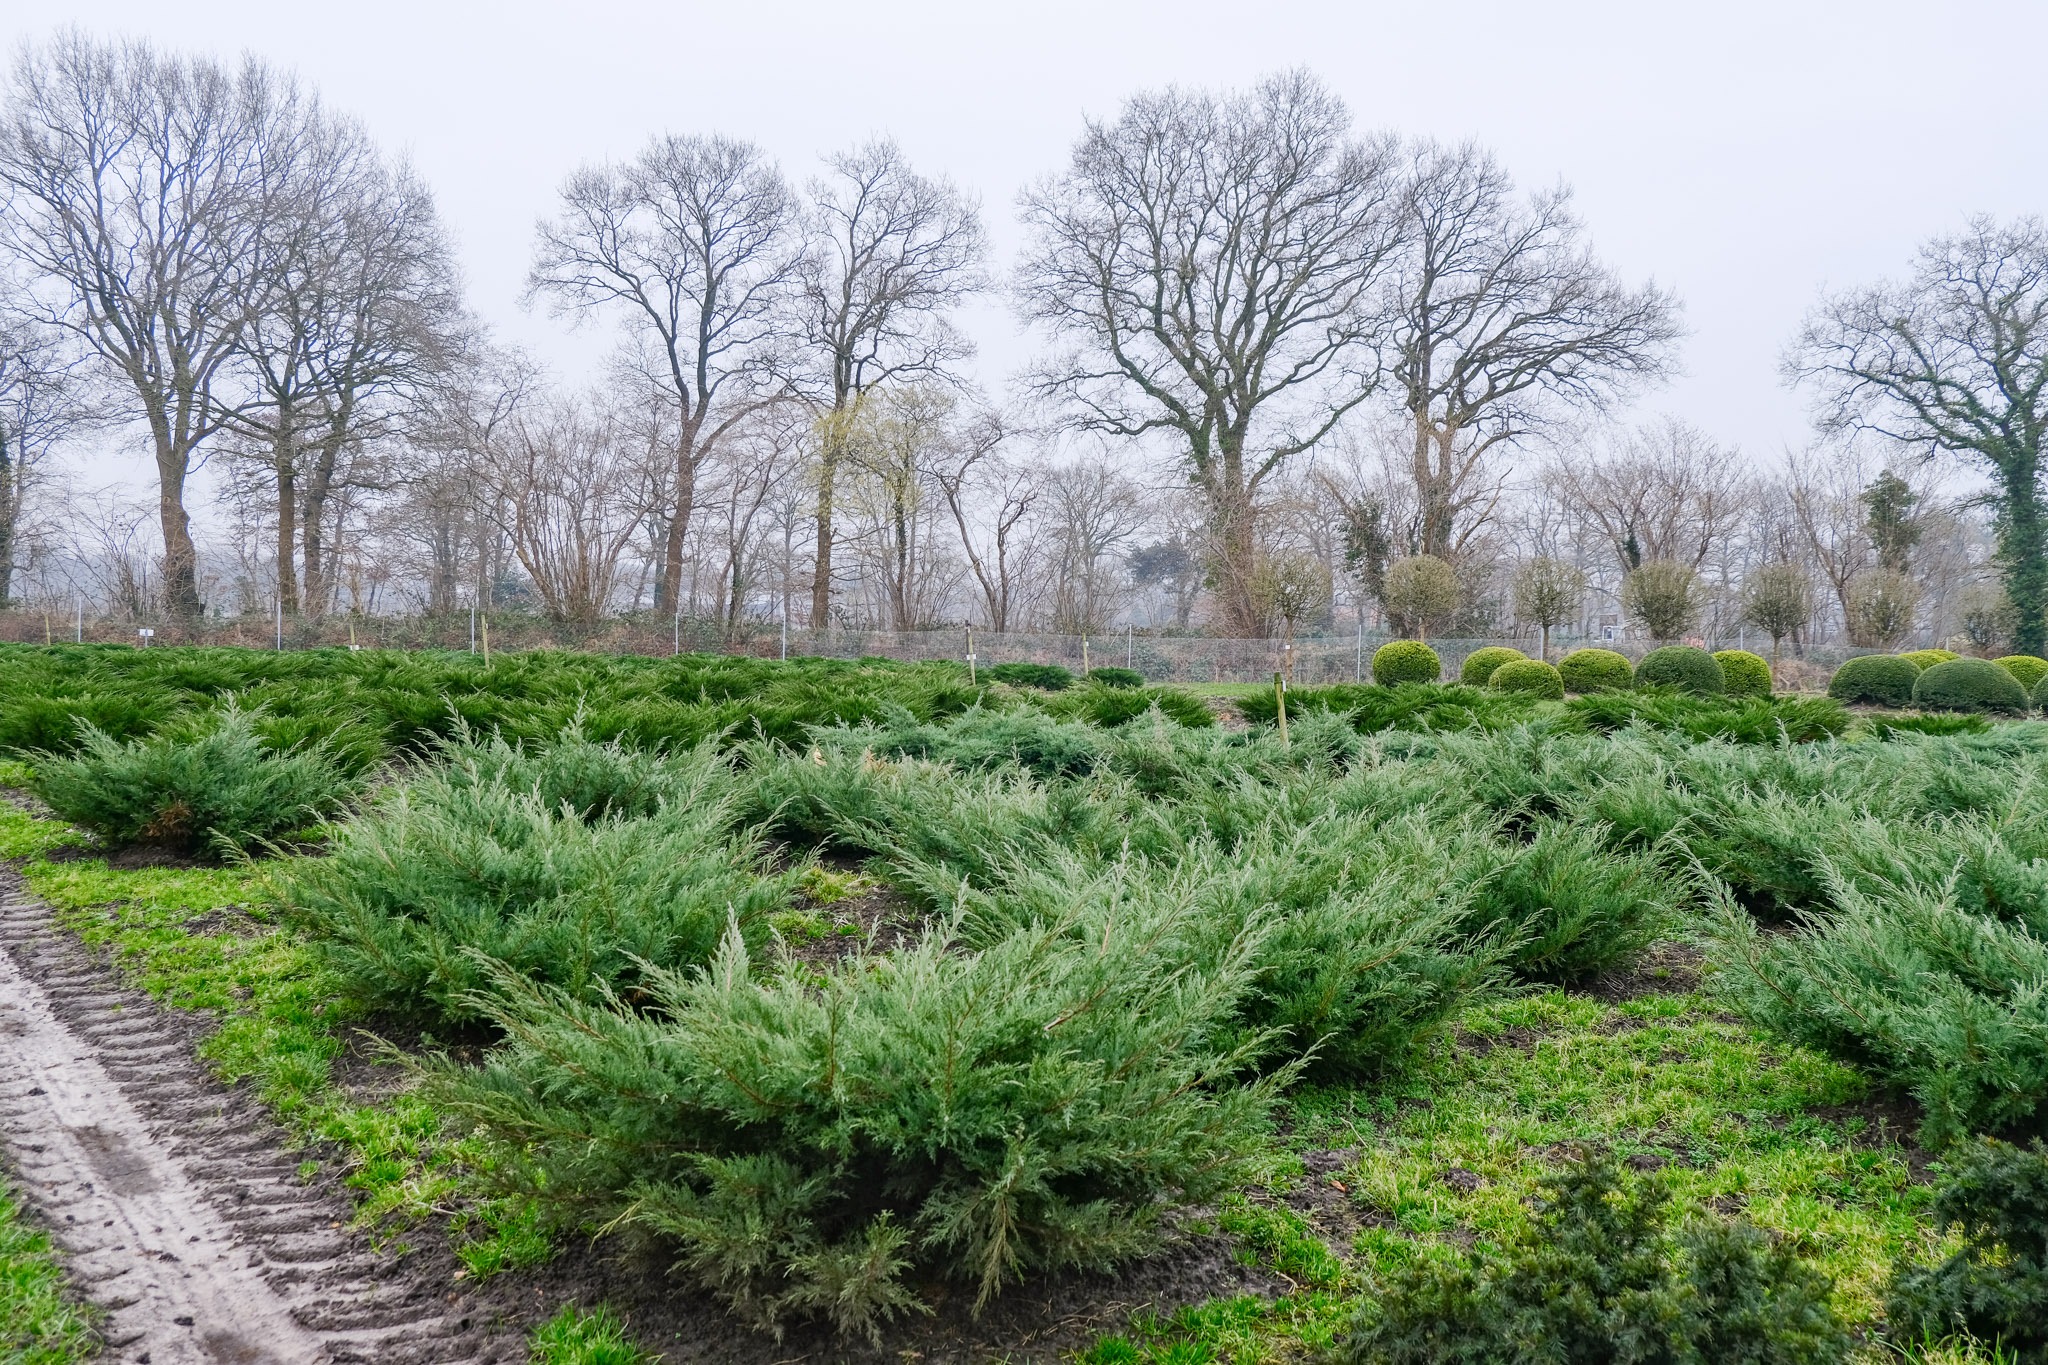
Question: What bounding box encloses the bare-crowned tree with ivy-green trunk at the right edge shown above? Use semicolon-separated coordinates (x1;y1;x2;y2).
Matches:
1786;217;2048;655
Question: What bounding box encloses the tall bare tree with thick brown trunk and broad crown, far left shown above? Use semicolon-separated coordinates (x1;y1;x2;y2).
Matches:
0;29;307;616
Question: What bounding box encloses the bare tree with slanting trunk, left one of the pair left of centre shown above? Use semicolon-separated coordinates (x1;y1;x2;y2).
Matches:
526;135;799;608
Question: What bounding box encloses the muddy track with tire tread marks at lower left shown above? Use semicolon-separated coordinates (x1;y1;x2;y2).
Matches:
0;868;524;1365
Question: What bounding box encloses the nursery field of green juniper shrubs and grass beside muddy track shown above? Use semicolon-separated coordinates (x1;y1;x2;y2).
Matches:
0;647;2048;1365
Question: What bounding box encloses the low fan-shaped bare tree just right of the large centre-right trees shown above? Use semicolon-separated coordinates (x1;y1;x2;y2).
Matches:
1548;417;1751;573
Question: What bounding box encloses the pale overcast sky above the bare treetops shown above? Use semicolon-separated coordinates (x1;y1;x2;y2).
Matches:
12;0;2048;470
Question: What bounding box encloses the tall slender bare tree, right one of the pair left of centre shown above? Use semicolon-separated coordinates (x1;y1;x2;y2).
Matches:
803;139;987;630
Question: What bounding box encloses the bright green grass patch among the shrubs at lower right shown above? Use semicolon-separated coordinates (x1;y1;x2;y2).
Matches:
1081;990;1941;1365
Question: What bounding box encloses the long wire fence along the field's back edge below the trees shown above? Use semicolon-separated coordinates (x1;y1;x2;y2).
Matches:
0;610;1868;686
